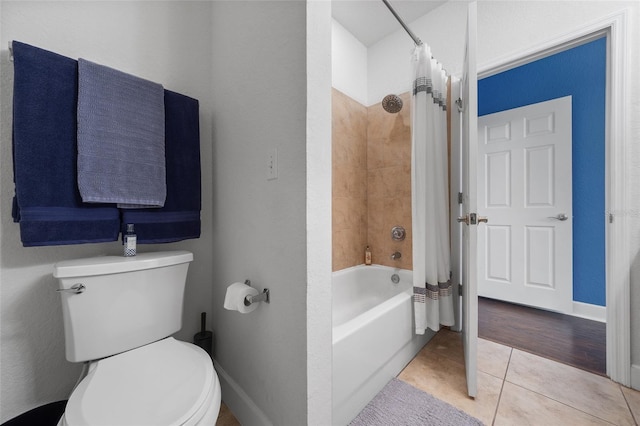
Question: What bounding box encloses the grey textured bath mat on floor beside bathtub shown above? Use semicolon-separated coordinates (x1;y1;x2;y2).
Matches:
349;379;483;426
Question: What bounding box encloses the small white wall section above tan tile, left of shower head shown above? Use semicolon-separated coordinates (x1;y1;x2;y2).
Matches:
331;19;369;106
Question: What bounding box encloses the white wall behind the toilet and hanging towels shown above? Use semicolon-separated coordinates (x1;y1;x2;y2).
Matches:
0;1;214;422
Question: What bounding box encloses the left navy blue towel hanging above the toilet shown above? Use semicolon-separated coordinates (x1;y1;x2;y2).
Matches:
13;41;120;247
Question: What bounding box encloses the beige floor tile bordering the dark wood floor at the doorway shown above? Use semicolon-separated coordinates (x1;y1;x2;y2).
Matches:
506;349;635;425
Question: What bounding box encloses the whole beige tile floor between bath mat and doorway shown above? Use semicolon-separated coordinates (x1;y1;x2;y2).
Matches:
398;330;640;426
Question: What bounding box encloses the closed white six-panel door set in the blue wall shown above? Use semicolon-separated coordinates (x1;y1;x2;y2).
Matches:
478;96;573;313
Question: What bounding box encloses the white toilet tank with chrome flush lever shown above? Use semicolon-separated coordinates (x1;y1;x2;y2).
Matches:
53;251;193;362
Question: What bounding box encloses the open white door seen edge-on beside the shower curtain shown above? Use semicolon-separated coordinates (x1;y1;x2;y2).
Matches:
460;2;478;397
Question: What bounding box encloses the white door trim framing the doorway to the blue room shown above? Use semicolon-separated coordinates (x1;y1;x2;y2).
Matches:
478;10;631;386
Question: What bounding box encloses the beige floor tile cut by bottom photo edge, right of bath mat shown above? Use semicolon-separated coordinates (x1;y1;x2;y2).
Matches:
493;382;610;426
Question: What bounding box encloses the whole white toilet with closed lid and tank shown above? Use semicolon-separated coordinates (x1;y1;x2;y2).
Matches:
53;251;221;426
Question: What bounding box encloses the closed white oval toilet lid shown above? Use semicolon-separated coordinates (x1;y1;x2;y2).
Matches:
65;337;217;426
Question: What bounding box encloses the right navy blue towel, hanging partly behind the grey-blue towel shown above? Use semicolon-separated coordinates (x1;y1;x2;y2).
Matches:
122;90;201;244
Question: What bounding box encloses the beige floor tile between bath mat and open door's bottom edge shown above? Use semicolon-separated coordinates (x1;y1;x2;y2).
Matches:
398;350;502;424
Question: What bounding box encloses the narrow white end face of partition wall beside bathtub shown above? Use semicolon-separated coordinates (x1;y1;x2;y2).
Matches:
307;1;333;425
